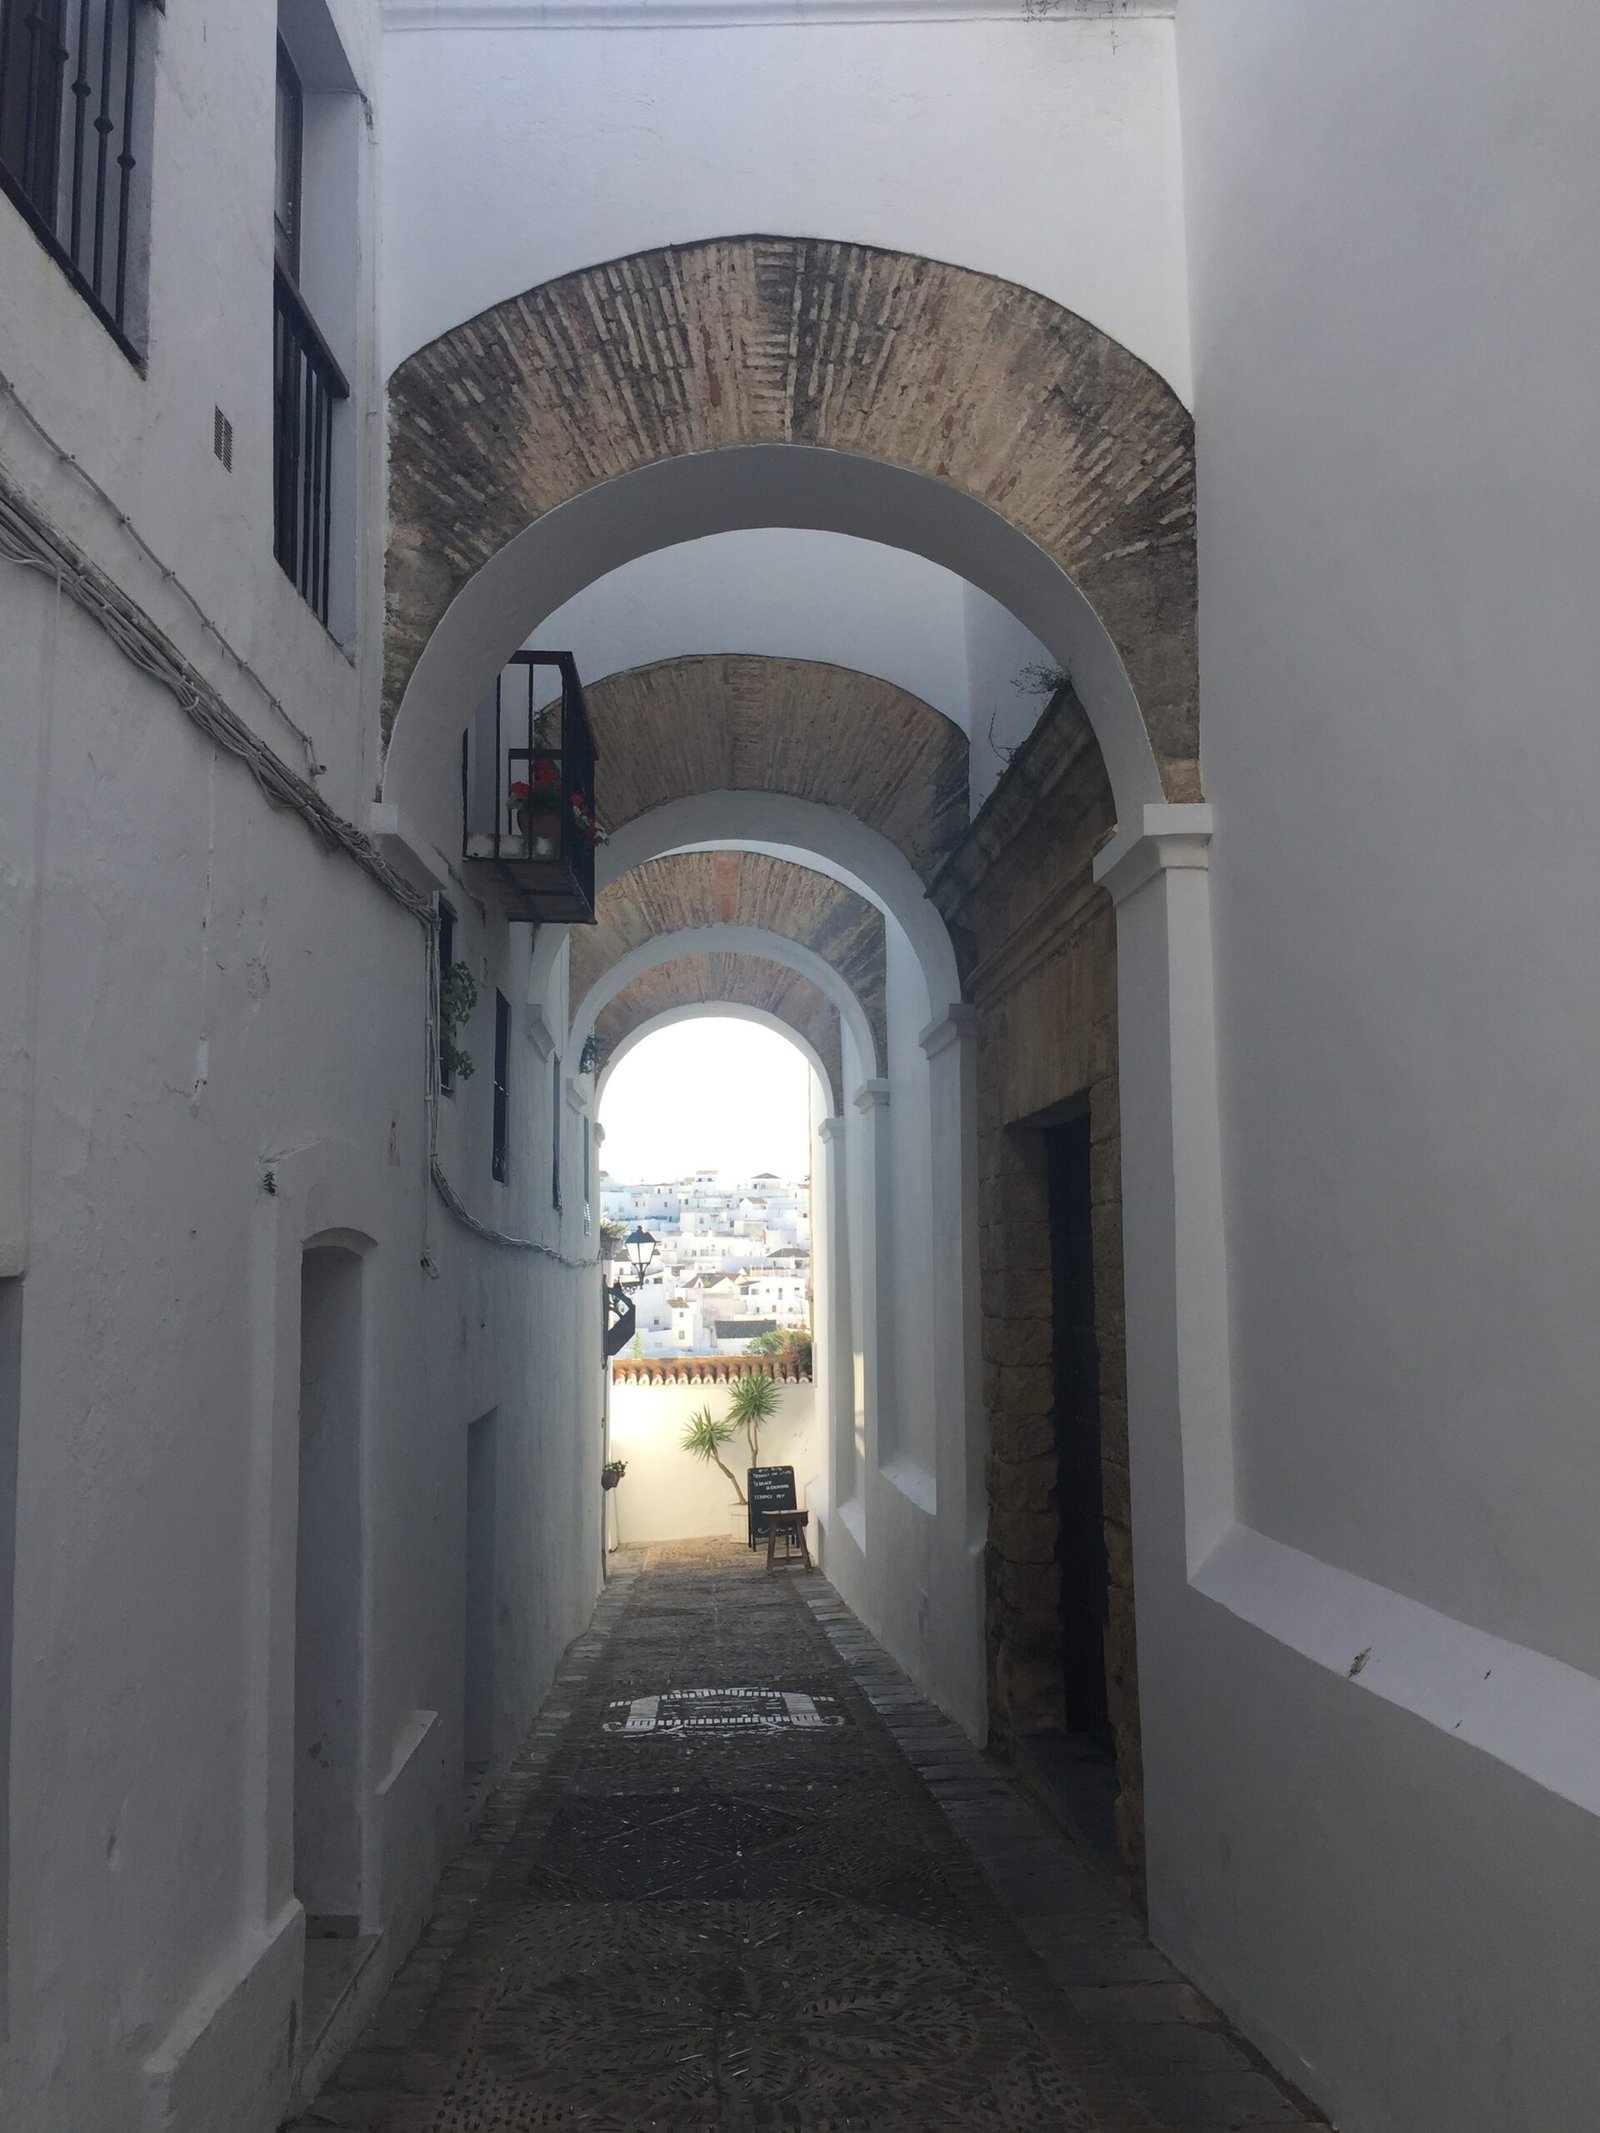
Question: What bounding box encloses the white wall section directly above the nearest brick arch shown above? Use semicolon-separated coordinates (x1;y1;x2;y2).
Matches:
382;0;1188;397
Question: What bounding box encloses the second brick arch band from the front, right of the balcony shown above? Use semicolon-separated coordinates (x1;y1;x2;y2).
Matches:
587;653;966;877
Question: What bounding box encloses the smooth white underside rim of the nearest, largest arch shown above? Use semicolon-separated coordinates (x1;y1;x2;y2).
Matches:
384;444;1165;861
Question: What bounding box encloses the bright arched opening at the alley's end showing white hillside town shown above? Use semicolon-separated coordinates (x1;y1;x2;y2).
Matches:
597;1019;828;1546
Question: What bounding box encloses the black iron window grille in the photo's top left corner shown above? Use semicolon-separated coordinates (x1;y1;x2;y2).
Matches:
0;0;151;358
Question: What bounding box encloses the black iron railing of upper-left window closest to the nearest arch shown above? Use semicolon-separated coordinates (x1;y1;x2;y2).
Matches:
273;267;350;623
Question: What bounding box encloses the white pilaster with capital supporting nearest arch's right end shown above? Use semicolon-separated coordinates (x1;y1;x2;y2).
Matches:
1094;806;1235;1578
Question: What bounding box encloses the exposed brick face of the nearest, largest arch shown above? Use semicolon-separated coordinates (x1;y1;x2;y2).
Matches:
386;237;1199;800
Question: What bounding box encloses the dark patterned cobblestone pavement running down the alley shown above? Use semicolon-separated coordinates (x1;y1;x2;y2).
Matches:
294;1542;1321;2133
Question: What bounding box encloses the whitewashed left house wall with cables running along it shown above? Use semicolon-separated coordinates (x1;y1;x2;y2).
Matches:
0;4;602;2133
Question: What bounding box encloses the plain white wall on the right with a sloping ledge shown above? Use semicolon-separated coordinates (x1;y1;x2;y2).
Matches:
1135;0;1600;2133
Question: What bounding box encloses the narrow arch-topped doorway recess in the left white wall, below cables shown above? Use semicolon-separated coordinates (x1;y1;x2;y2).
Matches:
294;1246;363;1941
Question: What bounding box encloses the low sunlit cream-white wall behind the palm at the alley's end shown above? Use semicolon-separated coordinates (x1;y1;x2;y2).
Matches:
610;1380;826;1546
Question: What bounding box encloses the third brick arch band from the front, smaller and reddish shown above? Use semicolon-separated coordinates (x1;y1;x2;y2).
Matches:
570;851;890;1056
